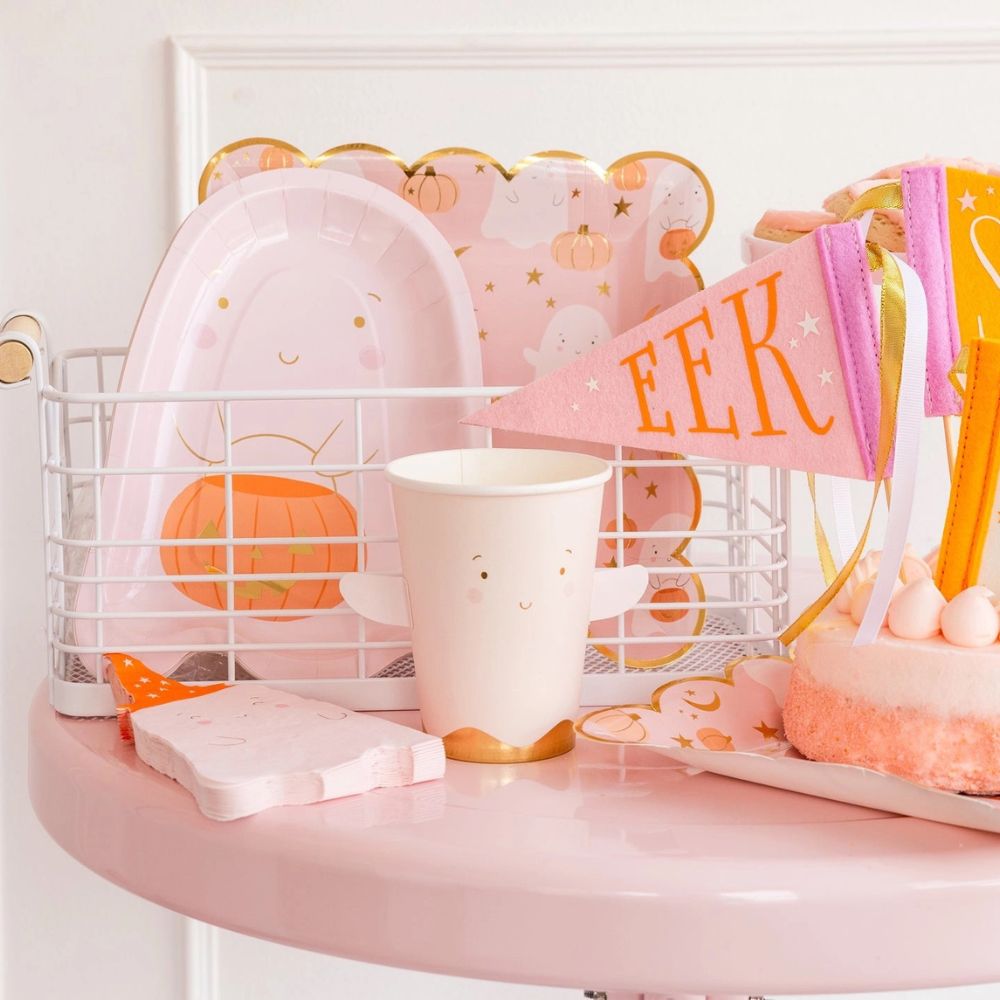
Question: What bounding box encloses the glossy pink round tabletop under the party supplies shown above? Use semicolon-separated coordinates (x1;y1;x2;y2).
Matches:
30;691;1000;994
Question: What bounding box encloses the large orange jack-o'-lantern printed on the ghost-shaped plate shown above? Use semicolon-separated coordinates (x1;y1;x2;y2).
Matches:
160;475;358;622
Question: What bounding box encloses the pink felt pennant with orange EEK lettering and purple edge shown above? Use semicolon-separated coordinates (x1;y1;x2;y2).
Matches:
468;222;879;479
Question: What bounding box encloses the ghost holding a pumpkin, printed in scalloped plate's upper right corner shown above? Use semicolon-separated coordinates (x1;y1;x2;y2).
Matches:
646;163;708;281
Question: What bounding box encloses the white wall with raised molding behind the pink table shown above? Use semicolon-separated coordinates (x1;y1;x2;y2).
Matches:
0;0;1000;1000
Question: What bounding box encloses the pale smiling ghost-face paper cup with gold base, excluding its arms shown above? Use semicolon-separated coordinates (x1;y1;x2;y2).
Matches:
385;448;611;763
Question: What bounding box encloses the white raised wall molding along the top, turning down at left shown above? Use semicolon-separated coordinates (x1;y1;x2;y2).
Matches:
171;25;1000;221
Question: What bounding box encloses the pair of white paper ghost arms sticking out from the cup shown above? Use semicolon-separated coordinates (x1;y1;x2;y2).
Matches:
340;566;648;627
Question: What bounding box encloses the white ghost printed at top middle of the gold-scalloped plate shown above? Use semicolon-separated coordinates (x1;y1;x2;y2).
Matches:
481;160;569;250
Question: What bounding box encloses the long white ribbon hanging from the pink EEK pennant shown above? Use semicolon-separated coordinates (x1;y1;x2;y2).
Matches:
854;254;927;646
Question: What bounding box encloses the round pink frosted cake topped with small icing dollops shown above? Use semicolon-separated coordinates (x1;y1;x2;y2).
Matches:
784;554;1000;794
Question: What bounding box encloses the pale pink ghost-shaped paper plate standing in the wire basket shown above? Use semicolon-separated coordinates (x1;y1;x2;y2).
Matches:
76;170;482;678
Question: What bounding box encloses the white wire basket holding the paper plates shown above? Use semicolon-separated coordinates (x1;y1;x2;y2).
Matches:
0;335;789;716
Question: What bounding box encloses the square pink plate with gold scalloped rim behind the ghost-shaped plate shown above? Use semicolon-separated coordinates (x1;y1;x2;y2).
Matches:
199;139;713;668
